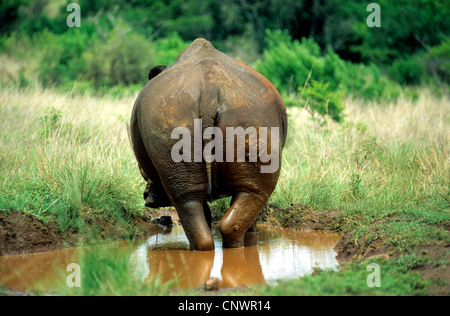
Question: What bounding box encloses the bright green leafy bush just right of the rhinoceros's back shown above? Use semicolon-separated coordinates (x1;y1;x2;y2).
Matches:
255;30;400;108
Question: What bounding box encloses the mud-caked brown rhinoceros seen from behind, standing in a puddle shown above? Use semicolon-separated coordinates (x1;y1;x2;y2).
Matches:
130;39;287;250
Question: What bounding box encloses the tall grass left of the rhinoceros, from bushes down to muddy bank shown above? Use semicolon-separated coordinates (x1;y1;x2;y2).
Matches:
0;87;142;234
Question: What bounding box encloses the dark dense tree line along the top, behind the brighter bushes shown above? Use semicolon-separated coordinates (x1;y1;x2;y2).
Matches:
0;0;449;65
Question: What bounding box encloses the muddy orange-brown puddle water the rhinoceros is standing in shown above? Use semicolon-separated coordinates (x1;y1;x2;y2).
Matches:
0;225;340;290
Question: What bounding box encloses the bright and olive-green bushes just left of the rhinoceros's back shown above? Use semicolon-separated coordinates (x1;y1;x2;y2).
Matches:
38;23;185;89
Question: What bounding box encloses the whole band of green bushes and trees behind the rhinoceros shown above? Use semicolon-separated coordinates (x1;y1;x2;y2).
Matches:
0;0;450;99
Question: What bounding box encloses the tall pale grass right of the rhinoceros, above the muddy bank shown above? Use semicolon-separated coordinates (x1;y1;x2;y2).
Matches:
270;91;450;217
